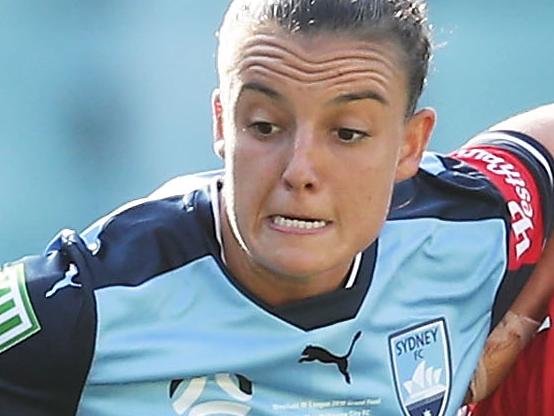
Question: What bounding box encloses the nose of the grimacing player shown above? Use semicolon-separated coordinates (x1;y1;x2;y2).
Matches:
282;132;322;191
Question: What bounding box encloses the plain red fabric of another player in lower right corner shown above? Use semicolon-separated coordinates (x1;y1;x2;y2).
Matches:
471;299;554;416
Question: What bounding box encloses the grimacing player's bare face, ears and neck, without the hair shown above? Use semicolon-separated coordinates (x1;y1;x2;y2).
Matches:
213;27;434;305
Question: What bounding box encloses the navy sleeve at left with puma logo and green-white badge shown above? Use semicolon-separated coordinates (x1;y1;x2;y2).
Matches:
0;231;96;416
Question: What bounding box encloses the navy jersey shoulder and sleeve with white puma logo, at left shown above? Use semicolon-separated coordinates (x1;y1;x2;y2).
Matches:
0;170;223;416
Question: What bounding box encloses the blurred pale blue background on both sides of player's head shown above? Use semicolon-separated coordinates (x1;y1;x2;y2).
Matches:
0;0;554;263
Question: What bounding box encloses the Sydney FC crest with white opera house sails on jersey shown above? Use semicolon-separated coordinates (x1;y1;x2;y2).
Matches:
389;319;451;416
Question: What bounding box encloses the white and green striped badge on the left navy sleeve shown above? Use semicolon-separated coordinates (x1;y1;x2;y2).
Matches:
0;264;40;353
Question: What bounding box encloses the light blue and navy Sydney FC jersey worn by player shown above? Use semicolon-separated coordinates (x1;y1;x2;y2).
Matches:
0;135;552;416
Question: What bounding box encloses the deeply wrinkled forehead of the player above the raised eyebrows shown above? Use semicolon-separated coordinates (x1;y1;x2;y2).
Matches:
220;27;406;107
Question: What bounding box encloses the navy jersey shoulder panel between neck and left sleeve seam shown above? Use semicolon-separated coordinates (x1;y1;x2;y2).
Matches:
82;172;219;288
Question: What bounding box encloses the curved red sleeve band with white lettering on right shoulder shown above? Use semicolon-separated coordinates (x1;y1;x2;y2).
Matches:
452;144;545;270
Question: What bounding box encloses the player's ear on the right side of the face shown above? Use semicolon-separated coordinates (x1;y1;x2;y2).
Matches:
396;108;437;182
